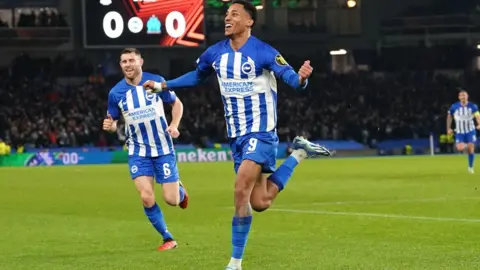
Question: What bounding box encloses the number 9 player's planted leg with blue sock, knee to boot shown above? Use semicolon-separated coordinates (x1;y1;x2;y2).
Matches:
227;160;262;269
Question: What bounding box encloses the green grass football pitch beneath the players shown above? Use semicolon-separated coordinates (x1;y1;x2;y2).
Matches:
0;156;480;270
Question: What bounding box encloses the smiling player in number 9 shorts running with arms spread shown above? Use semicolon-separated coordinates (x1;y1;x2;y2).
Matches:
144;1;330;269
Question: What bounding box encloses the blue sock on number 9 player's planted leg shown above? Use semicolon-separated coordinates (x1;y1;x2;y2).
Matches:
232;216;252;259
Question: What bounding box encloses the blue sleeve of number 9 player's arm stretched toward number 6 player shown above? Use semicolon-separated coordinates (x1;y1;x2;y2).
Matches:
166;47;214;89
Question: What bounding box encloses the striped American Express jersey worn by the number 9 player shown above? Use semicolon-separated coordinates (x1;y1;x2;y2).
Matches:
197;36;306;138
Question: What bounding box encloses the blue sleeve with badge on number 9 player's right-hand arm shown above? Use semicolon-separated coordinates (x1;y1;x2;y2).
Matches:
262;45;307;89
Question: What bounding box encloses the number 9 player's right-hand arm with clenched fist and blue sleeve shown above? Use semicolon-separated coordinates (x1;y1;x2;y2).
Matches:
265;46;313;89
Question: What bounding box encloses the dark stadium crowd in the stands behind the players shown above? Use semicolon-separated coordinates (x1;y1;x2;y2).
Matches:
0;52;480;150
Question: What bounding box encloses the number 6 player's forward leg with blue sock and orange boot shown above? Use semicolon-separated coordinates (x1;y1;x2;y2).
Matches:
134;176;178;250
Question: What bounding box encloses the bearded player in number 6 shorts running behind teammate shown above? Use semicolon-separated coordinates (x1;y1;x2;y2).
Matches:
103;48;188;250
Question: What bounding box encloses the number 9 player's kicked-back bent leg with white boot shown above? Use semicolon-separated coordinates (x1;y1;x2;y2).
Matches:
250;137;331;212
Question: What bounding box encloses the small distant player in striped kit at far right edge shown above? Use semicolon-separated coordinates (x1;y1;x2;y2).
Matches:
447;90;480;173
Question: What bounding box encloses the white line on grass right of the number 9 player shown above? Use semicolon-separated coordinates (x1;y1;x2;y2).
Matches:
267;208;480;223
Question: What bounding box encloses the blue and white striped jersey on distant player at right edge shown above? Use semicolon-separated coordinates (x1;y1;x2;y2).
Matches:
448;102;479;134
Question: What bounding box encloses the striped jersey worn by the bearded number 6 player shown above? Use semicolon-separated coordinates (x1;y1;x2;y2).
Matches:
108;72;177;157
